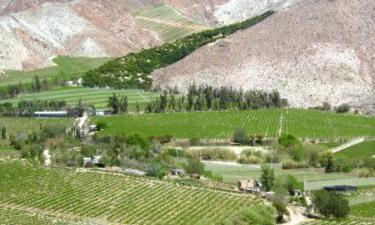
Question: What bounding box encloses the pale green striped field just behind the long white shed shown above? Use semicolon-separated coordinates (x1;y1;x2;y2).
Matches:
0;88;159;110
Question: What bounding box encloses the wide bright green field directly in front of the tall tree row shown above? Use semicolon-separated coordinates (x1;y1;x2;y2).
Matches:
96;109;375;139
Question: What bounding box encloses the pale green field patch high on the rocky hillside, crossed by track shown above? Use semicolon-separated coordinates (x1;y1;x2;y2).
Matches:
135;5;207;42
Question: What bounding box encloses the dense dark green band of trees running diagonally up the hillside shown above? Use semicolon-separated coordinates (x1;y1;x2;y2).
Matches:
83;11;273;89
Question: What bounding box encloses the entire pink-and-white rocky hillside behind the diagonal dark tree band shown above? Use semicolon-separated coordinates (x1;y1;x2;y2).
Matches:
0;0;302;70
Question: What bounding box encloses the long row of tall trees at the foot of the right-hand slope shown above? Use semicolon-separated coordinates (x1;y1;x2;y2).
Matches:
145;85;288;113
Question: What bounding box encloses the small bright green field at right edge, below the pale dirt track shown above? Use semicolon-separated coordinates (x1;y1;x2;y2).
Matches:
335;141;375;162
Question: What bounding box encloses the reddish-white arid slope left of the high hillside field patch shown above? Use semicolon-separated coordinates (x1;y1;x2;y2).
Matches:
0;0;161;70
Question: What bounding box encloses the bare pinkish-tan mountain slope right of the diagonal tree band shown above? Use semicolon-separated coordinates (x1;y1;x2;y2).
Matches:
153;0;375;107
